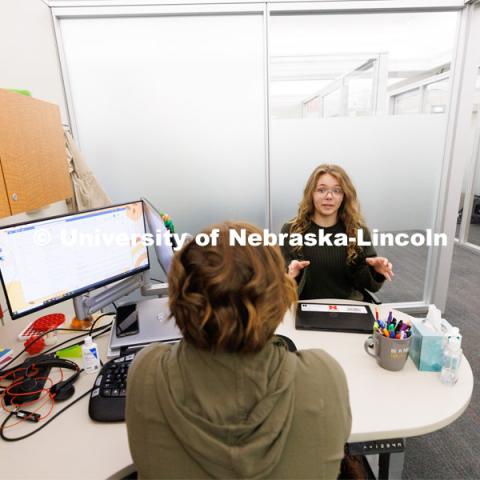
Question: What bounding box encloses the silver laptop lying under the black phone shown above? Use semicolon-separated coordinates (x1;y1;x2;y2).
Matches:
110;298;182;351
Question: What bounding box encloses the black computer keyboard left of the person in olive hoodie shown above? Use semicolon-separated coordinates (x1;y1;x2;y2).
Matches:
88;352;138;422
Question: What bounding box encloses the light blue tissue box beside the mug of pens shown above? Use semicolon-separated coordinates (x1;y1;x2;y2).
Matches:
409;318;450;372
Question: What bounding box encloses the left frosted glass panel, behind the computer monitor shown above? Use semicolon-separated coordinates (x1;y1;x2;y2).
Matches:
60;14;266;233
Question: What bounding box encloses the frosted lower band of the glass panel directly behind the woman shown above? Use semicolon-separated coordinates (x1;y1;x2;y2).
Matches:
270;115;446;231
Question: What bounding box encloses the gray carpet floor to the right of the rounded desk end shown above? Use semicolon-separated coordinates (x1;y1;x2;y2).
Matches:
400;246;480;480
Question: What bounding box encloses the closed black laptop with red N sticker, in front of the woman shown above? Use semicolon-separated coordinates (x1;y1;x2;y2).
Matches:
295;301;375;333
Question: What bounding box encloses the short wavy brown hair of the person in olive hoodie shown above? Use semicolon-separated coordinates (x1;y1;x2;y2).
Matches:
168;222;297;353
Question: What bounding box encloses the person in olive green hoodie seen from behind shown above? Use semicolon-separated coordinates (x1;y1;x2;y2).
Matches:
126;223;351;479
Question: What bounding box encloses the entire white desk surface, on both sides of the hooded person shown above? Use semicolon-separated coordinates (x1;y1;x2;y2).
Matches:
0;302;473;479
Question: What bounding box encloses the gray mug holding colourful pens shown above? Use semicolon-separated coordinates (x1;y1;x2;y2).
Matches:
364;332;412;372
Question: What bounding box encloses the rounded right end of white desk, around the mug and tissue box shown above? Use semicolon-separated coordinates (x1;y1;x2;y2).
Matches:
278;301;473;442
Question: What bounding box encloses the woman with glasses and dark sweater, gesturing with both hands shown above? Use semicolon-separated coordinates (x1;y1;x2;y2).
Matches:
282;164;393;300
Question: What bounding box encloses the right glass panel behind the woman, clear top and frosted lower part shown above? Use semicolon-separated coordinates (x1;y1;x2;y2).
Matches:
269;12;458;302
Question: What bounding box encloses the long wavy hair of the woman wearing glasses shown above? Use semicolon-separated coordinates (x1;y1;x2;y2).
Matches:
290;163;365;264
